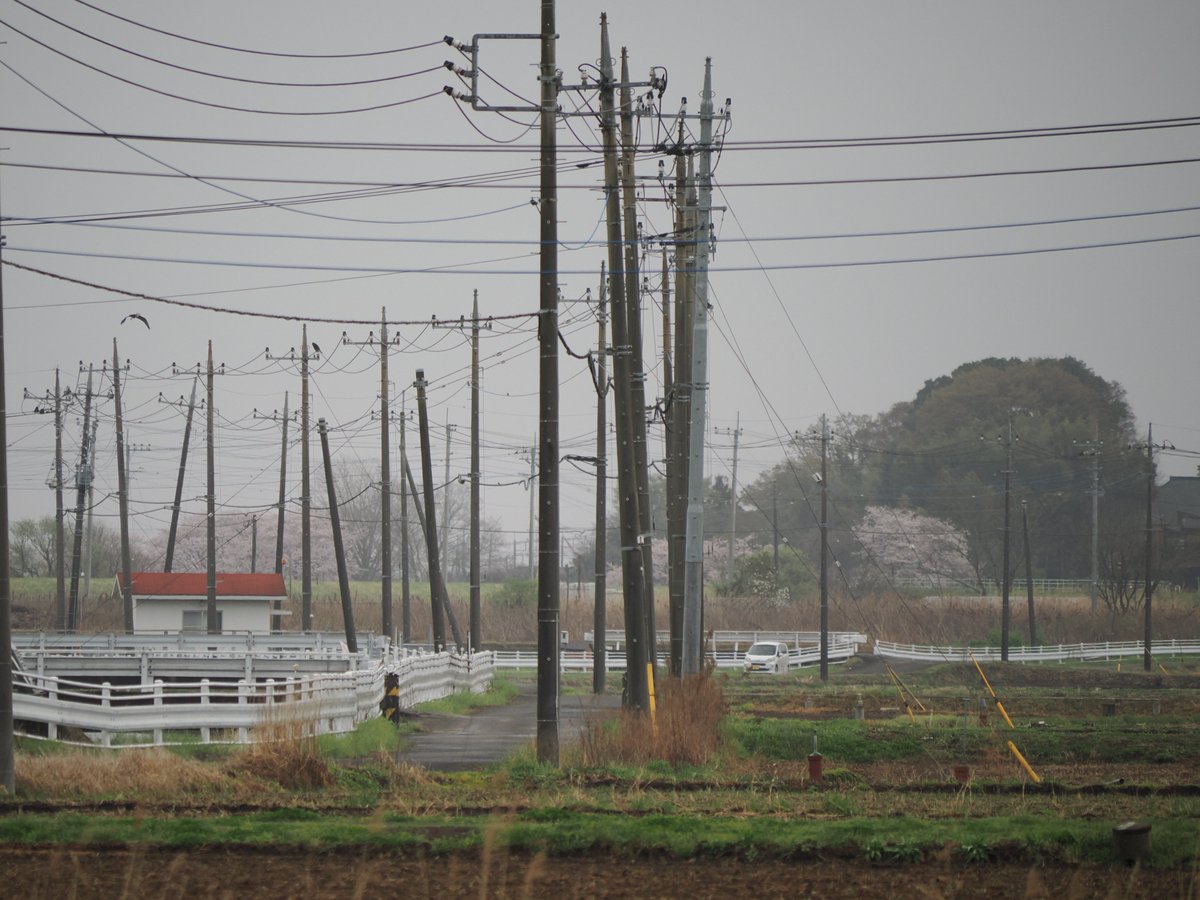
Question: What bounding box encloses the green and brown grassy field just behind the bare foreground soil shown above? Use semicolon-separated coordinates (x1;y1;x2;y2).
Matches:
0;668;1200;869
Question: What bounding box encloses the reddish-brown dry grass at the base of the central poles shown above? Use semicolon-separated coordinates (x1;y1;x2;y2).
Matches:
578;672;726;766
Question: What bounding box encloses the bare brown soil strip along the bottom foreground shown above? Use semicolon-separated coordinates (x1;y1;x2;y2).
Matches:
0;847;1200;900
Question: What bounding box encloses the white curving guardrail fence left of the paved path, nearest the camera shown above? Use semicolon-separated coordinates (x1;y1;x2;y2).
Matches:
13;653;494;746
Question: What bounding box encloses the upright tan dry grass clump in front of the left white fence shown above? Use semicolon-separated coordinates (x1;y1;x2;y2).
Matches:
226;707;335;790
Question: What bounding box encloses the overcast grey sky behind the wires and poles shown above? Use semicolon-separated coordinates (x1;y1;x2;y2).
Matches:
0;0;1200;564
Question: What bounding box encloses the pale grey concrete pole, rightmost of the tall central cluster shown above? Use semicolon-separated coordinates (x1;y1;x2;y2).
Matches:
683;59;713;676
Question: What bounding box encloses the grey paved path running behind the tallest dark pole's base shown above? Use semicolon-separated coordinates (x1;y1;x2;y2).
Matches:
396;680;620;772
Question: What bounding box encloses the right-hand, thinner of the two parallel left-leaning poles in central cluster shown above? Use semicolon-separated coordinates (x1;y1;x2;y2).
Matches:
620;47;658;676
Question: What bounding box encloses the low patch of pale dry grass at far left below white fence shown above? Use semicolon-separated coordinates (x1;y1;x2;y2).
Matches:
16;749;235;799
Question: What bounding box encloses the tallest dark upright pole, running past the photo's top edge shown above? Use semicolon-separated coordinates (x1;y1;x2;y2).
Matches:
538;0;560;766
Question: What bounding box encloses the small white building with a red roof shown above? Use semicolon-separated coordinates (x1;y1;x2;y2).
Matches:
116;572;287;634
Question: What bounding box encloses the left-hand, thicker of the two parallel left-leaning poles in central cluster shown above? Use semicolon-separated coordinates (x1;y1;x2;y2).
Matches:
600;14;649;712
